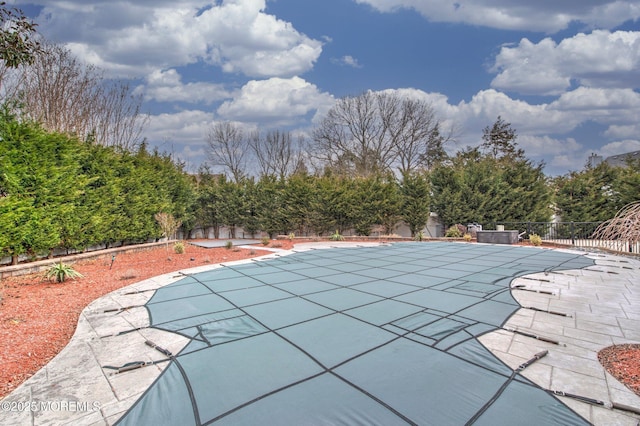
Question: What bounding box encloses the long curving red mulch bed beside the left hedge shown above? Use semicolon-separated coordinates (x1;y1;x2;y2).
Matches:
0;240;292;398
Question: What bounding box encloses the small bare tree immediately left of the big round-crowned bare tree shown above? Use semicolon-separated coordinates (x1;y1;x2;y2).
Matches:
249;130;302;179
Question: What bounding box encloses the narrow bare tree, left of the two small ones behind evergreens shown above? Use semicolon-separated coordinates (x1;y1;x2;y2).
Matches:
206;121;249;182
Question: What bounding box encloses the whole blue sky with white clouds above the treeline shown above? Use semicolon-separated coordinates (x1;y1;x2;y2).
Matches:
15;0;640;175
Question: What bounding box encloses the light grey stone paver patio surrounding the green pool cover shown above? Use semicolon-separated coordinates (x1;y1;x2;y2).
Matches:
0;242;640;426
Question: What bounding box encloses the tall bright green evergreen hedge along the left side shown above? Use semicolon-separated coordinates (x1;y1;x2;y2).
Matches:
0;110;195;263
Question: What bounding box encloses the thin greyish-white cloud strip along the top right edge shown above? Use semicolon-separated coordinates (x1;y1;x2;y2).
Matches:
355;0;640;33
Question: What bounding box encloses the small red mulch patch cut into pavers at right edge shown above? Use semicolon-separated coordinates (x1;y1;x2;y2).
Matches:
598;344;640;396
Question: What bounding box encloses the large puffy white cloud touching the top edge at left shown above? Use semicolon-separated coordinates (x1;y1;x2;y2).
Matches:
33;0;322;77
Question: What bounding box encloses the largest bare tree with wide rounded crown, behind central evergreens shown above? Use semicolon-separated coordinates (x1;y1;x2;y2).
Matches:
313;91;448;176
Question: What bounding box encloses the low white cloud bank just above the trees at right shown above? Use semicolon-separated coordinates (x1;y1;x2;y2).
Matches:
372;88;640;174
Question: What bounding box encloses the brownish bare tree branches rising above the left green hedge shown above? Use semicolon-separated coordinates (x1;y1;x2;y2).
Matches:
5;43;146;149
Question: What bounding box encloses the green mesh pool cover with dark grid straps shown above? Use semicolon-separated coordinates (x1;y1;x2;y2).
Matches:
118;243;593;425
